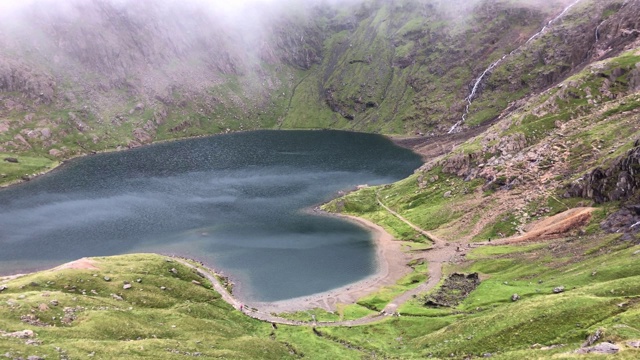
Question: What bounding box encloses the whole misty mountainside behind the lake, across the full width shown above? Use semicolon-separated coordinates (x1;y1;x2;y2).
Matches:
0;0;637;186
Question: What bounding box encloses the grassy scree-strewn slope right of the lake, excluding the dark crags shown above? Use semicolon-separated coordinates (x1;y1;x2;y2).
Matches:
327;51;640;240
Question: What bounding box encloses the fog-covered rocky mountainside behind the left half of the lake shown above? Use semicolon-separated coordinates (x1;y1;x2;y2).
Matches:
0;1;318;163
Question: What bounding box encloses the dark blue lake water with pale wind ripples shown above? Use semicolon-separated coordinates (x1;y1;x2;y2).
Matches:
0;131;421;301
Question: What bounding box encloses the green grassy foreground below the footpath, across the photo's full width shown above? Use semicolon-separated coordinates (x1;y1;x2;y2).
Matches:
0;236;640;359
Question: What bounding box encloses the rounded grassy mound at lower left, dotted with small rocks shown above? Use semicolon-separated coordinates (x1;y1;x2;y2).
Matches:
0;255;296;359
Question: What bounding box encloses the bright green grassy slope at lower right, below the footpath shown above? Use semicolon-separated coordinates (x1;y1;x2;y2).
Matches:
324;237;640;359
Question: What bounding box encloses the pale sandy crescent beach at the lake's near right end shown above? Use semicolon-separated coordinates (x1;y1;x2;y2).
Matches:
246;214;411;313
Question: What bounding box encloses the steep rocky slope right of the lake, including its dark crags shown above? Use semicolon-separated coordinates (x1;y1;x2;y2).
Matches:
330;50;640;240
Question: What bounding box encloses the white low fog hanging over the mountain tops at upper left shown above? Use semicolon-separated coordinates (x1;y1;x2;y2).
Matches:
0;0;570;119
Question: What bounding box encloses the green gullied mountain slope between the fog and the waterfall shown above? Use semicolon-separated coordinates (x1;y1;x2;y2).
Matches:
285;1;576;134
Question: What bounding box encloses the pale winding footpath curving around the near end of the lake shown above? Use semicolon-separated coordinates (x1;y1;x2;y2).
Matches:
174;195;460;327
